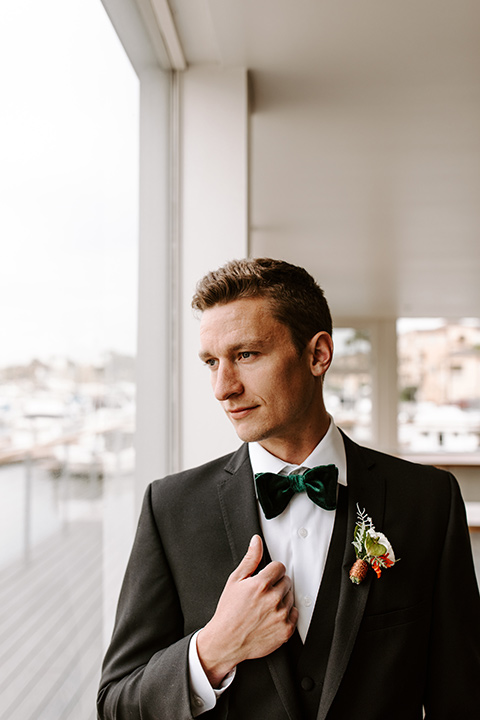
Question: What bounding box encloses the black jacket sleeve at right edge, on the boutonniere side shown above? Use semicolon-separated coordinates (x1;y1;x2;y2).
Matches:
425;475;480;720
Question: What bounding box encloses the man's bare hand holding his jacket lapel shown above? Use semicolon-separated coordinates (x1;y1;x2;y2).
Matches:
197;535;298;687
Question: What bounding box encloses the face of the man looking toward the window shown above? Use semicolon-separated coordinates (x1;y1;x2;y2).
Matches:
200;298;321;455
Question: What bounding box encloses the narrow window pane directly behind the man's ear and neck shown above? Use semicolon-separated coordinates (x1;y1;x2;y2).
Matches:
325;328;372;442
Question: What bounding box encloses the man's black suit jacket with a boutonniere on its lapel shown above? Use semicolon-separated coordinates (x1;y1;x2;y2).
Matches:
98;438;480;720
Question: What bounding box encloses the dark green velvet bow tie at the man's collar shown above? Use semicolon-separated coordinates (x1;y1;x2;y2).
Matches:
255;465;338;520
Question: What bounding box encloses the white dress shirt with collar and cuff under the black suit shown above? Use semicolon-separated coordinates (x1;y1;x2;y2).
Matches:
189;419;347;717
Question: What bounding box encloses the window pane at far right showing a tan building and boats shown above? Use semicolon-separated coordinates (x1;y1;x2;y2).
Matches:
397;318;480;452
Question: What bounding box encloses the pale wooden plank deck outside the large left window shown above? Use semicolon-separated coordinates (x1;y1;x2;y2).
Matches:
0;522;103;720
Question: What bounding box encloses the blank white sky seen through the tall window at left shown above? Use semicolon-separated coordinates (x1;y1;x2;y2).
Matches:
0;0;139;367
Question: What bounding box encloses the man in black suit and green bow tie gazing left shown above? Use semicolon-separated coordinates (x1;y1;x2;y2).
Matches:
98;259;480;720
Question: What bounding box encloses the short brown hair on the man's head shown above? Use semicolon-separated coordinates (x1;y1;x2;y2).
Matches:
192;258;332;353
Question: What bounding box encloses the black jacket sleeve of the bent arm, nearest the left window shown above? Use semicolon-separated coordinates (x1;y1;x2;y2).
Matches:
97;487;197;720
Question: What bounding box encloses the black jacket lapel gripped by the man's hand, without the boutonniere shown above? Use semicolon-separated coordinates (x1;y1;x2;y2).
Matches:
217;445;301;720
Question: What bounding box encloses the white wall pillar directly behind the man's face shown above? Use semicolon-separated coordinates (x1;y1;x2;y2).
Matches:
176;67;248;468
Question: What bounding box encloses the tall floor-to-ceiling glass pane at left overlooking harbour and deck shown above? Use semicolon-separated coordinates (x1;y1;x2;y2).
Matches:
0;0;139;720
